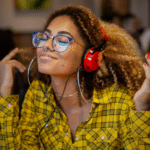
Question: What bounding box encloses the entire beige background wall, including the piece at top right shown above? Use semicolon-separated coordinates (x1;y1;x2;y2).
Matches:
0;0;150;32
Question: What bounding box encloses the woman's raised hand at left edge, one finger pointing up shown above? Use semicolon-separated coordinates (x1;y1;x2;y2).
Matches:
0;48;26;96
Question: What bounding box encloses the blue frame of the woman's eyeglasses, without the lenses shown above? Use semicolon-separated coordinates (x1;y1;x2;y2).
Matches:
32;31;75;53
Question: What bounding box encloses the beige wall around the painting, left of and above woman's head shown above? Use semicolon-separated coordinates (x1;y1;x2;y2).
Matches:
0;0;100;32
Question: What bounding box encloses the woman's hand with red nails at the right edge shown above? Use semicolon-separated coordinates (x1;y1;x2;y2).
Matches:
134;54;150;111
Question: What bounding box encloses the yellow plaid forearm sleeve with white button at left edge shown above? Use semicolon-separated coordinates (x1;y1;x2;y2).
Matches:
0;95;19;150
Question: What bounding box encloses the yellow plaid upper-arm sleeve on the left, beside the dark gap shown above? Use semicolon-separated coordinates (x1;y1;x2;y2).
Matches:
15;81;40;150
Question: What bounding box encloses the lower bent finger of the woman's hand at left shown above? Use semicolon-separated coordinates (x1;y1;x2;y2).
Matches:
7;60;26;73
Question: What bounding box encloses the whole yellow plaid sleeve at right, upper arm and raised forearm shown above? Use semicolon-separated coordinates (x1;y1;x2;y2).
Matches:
115;87;150;150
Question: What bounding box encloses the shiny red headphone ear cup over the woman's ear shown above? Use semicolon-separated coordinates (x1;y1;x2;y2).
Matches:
82;47;100;72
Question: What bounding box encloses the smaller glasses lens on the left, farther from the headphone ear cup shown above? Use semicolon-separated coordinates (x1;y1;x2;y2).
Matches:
33;32;48;48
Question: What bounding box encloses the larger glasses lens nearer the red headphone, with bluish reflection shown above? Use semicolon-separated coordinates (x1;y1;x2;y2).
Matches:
53;35;70;52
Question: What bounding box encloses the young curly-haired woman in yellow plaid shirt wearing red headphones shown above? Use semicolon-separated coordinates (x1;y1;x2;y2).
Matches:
0;6;150;150
